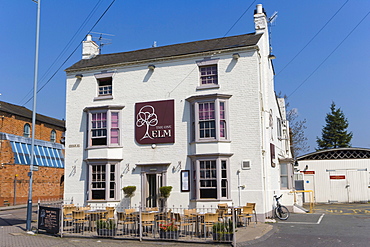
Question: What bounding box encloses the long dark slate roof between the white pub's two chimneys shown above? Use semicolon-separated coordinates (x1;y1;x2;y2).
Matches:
66;33;262;72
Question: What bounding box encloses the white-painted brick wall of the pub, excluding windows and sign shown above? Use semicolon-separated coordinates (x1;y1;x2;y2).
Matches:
65;26;286;218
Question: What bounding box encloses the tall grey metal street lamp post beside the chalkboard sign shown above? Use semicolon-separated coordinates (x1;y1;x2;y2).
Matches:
26;0;41;231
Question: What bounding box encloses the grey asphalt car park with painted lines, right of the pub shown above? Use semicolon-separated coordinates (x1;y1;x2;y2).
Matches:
246;204;370;247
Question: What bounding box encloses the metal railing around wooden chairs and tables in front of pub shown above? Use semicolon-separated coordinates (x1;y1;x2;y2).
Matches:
40;202;258;244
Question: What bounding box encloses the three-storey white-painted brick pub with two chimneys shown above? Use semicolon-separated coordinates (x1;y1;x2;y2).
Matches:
64;5;293;218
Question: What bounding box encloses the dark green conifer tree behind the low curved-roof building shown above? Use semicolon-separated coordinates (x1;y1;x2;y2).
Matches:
316;102;352;150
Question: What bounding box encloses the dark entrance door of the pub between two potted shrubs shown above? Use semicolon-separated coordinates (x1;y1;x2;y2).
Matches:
145;173;163;207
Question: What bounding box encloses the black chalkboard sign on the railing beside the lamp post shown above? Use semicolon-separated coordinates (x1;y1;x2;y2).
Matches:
38;206;60;234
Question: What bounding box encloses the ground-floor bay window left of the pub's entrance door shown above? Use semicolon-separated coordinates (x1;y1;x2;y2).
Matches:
88;161;119;201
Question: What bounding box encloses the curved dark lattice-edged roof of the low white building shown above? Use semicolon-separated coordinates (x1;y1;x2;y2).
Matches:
297;148;370;161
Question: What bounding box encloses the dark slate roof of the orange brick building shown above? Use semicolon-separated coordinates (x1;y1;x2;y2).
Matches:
0;101;65;128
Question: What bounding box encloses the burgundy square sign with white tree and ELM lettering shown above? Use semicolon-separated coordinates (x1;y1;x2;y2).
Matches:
135;100;175;144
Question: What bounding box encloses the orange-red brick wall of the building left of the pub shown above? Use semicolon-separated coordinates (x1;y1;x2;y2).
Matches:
0;111;64;206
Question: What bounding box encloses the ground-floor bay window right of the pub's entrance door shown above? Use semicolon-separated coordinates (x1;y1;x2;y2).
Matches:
192;157;230;200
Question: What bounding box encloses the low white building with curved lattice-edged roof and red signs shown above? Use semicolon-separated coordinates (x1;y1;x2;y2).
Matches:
297;148;370;203
